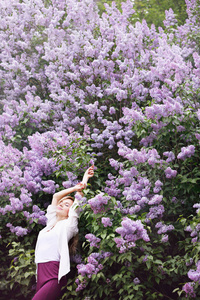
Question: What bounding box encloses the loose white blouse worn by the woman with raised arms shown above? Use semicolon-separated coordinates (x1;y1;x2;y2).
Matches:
35;200;79;282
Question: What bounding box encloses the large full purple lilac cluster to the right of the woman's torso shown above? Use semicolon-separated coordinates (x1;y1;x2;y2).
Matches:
114;217;150;253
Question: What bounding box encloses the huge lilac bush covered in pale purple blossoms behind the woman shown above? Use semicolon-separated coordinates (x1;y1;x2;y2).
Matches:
0;0;200;299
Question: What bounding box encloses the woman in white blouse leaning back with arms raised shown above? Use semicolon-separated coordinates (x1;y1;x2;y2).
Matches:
32;166;94;300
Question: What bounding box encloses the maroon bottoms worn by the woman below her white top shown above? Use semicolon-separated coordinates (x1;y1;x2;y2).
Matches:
32;261;67;300
